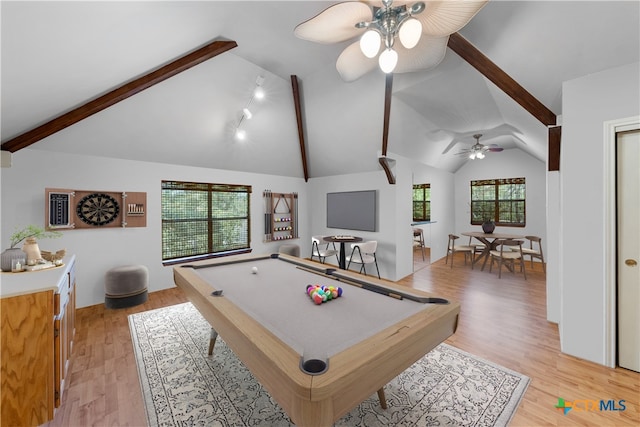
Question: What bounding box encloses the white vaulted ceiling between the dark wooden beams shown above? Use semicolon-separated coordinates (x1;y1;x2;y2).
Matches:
0;0;640;178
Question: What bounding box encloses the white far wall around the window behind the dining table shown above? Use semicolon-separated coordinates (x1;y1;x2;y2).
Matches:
451;149;553;251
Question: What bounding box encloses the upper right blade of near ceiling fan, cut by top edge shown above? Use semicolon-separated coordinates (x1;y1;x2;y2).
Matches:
418;0;488;37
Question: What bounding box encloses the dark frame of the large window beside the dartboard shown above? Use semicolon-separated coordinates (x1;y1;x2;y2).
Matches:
160;180;252;265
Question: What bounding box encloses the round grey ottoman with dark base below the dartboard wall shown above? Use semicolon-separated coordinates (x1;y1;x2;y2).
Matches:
104;265;149;308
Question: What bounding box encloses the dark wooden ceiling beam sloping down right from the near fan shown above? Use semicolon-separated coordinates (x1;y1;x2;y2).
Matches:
448;33;556;126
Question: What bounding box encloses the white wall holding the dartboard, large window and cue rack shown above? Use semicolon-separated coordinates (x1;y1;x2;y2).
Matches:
0;149;311;307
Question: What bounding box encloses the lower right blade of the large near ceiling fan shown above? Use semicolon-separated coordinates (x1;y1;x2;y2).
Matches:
393;36;449;73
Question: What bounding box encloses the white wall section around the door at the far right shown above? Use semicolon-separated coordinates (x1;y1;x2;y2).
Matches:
549;63;640;364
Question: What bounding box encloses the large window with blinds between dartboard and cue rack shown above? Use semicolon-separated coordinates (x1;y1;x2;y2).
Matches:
161;181;251;261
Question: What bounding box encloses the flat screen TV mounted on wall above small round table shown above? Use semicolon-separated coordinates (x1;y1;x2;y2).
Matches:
327;190;377;231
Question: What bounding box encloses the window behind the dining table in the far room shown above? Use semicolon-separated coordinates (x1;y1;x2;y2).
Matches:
471;178;525;227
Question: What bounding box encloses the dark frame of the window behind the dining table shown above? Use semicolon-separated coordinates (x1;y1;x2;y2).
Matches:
469;177;527;228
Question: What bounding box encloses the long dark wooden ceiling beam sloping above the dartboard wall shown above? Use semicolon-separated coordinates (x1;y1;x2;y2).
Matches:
2;40;238;153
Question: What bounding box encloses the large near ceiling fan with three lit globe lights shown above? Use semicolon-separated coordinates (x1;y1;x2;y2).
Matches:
294;0;488;82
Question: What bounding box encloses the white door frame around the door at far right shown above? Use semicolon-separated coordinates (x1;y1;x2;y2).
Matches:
602;116;640;368
